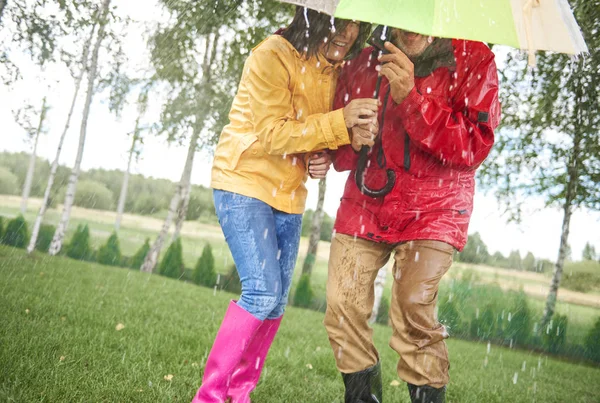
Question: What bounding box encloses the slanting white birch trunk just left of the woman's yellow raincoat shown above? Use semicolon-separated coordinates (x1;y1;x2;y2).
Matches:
140;131;200;273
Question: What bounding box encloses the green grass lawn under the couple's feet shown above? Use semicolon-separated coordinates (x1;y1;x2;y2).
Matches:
0;246;600;402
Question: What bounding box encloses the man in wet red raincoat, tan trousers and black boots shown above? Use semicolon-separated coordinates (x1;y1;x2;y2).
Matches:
324;29;500;402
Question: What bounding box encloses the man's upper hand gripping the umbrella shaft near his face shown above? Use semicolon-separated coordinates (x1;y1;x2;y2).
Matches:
379;42;415;104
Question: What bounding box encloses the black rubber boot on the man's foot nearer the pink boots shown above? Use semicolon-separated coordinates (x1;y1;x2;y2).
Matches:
342;362;383;403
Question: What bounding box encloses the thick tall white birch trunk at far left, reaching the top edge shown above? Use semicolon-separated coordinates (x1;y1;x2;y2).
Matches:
48;0;110;256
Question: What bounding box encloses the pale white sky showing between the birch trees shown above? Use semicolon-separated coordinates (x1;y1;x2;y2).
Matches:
0;0;600;260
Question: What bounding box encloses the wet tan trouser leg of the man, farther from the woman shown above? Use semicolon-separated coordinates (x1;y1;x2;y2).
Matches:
390;241;454;388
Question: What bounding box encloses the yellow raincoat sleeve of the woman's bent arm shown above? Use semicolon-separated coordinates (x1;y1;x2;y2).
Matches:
244;49;350;155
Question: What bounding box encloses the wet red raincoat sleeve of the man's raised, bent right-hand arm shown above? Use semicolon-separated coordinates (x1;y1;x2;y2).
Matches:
396;52;500;170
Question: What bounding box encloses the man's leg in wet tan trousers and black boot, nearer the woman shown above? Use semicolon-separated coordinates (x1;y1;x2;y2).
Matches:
324;234;392;402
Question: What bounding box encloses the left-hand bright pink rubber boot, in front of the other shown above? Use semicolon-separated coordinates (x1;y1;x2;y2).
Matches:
192;301;263;403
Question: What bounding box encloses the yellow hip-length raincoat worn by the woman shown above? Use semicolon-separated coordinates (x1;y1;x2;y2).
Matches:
211;35;350;214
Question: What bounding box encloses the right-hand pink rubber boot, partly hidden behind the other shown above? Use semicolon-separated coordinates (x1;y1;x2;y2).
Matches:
227;317;281;403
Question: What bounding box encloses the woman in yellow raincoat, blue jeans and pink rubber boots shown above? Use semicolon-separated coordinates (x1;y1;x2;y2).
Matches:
193;7;377;403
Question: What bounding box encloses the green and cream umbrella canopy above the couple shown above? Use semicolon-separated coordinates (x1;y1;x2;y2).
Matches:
281;0;588;61
